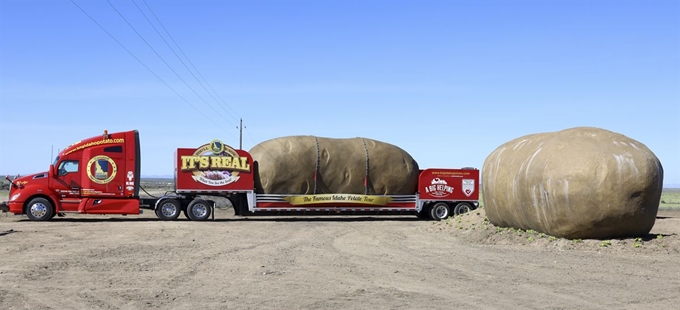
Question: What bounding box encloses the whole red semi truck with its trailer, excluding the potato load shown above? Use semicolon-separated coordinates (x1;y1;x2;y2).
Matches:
0;130;479;221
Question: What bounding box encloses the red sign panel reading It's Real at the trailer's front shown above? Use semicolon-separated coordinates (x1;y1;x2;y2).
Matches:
175;140;254;191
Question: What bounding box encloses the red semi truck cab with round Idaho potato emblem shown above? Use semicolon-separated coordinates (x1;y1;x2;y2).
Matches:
7;130;140;221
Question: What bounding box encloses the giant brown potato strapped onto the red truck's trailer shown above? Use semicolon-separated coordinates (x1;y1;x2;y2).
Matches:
250;136;420;195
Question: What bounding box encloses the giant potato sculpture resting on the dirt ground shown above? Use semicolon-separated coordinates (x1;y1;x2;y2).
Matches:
482;127;663;239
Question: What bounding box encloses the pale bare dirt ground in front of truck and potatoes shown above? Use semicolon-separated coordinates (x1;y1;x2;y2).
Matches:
0;209;680;309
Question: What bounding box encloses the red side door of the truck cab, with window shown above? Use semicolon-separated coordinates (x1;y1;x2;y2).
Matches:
53;159;81;212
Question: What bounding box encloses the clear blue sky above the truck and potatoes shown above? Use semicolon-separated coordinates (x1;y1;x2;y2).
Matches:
0;0;680;187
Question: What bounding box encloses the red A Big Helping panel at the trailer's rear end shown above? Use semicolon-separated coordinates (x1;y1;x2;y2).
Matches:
418;169;479;200
